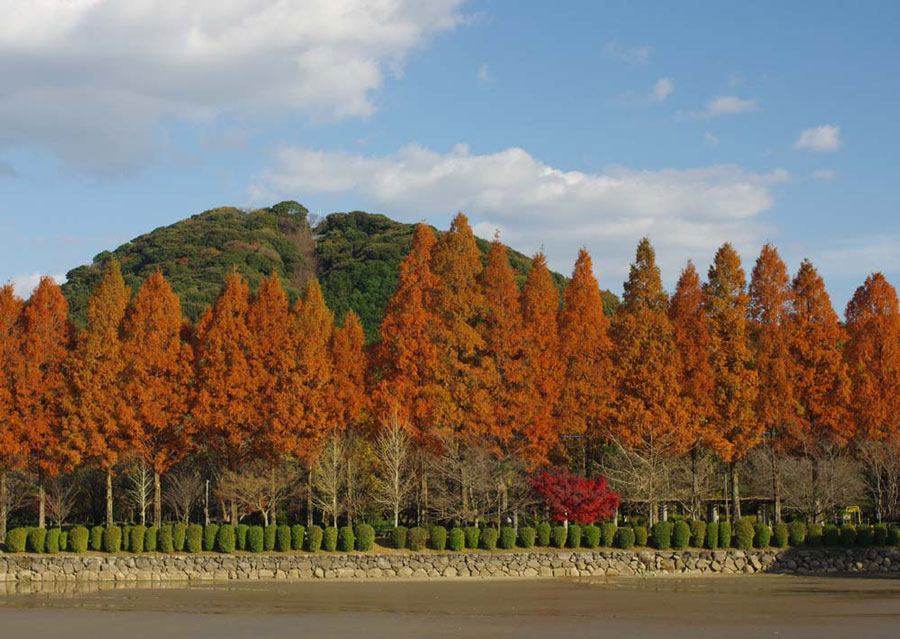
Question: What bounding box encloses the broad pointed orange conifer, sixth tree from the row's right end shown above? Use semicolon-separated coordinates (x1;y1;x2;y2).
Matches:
610;238;694;525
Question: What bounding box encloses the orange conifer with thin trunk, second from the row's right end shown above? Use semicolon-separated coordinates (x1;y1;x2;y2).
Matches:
785;260;853;522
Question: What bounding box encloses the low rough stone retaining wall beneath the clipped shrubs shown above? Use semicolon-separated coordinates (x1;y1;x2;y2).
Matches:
0;548;900;583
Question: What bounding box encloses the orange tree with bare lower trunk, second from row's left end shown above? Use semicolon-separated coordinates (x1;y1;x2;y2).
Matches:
16;277;73;527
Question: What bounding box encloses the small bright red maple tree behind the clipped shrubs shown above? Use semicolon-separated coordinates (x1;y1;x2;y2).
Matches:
531;469;619;524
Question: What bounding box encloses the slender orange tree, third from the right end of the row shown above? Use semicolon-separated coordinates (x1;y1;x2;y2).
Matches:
748;244;796;522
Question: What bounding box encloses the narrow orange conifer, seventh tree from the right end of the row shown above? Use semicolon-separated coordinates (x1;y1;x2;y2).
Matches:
557;249;614;475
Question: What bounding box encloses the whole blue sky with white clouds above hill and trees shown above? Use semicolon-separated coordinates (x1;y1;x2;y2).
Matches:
0;0;900;311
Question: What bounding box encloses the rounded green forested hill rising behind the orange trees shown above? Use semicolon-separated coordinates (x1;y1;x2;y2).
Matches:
63;202;618;339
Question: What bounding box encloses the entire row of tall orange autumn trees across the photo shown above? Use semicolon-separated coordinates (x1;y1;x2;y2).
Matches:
0;214;900;531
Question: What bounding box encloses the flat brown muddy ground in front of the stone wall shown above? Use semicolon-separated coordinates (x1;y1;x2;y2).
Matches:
0;576;900;639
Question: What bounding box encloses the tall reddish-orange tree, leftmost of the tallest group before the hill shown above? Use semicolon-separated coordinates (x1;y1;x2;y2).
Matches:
373;224;438;442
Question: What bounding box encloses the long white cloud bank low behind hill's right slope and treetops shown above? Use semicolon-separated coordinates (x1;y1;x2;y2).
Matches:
251;145;790;288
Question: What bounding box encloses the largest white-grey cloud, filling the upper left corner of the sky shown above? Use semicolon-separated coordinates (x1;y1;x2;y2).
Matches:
0;0;464;173
